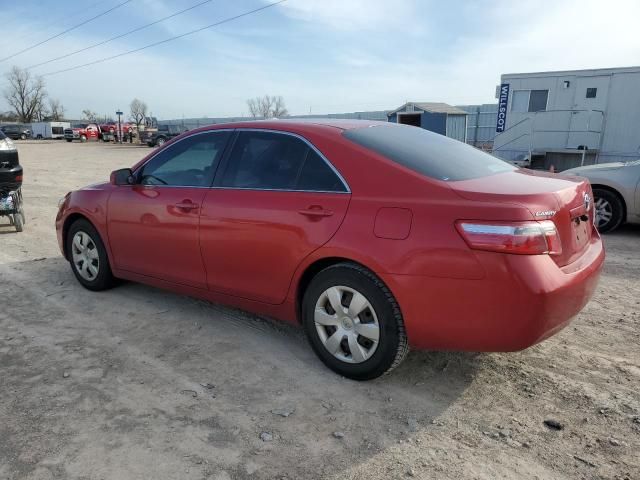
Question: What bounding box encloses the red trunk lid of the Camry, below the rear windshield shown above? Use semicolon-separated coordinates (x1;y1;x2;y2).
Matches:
448;169;597;266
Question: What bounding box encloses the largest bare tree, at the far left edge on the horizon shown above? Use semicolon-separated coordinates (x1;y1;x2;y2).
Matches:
4;66;47;123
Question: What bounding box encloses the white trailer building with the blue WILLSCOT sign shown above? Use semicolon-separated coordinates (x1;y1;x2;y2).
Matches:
493;67;640;170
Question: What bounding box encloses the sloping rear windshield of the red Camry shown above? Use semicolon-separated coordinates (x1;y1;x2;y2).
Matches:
343;124;516;181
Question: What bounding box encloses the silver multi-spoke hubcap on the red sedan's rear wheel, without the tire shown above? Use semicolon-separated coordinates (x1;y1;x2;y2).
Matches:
314;286;380;363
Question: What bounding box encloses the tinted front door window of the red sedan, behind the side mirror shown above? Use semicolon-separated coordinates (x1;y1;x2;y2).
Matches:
138;131;231;187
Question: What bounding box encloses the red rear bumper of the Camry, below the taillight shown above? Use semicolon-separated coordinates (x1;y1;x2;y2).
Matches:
381;235;605;352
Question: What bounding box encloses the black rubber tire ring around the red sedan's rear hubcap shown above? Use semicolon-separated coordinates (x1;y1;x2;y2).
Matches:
302;263;409;380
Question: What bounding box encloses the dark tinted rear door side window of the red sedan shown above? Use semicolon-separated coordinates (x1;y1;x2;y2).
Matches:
220;132;346;192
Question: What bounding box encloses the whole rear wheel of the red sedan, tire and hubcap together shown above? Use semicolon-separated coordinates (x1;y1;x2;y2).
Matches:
302;263;409;380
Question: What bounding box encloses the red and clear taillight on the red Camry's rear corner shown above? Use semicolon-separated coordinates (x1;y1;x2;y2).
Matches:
456;220;562;255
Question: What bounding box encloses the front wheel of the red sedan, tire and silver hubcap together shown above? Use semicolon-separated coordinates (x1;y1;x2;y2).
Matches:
67;220;115;291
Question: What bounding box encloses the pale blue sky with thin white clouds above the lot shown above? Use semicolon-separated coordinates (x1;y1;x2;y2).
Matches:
0;0;640;119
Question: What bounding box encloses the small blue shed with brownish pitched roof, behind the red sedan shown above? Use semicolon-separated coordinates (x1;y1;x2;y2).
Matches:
387;102;467;142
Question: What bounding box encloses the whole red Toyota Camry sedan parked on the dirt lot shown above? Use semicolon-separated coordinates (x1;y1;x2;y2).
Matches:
56;120;604;380
